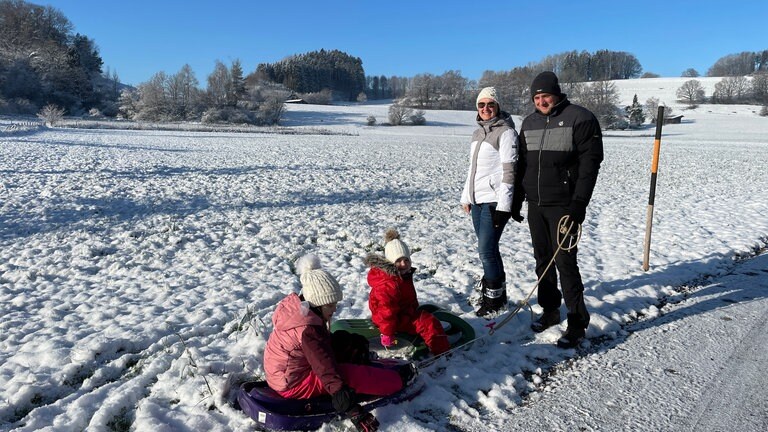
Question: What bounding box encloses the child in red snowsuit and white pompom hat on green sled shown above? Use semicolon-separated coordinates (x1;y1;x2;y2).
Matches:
365;229;450;355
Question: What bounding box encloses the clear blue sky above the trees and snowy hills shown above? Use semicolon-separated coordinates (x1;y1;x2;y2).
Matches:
32;0;768;85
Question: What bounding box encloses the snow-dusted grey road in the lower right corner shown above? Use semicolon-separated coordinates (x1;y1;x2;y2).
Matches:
467;254;768;432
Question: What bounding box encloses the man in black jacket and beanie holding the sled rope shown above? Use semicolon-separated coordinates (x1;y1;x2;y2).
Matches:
516;72;603;348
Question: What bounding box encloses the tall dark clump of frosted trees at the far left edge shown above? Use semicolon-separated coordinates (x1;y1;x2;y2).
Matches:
0;0;119;114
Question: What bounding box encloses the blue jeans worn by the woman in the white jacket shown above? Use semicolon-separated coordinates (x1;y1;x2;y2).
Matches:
471;203;504;281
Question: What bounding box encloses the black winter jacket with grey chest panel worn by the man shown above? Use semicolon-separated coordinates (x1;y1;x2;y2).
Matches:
515;99;603;206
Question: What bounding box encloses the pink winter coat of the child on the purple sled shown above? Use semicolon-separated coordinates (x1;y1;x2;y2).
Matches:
264;294;344;394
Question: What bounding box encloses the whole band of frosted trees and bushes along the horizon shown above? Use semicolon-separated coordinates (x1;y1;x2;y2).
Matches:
0;0;768;123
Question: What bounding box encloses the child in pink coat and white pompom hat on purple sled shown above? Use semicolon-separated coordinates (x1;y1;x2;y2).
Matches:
264;255;407;431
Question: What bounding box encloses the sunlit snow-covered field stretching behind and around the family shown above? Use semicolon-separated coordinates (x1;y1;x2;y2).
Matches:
0;78;768;431
